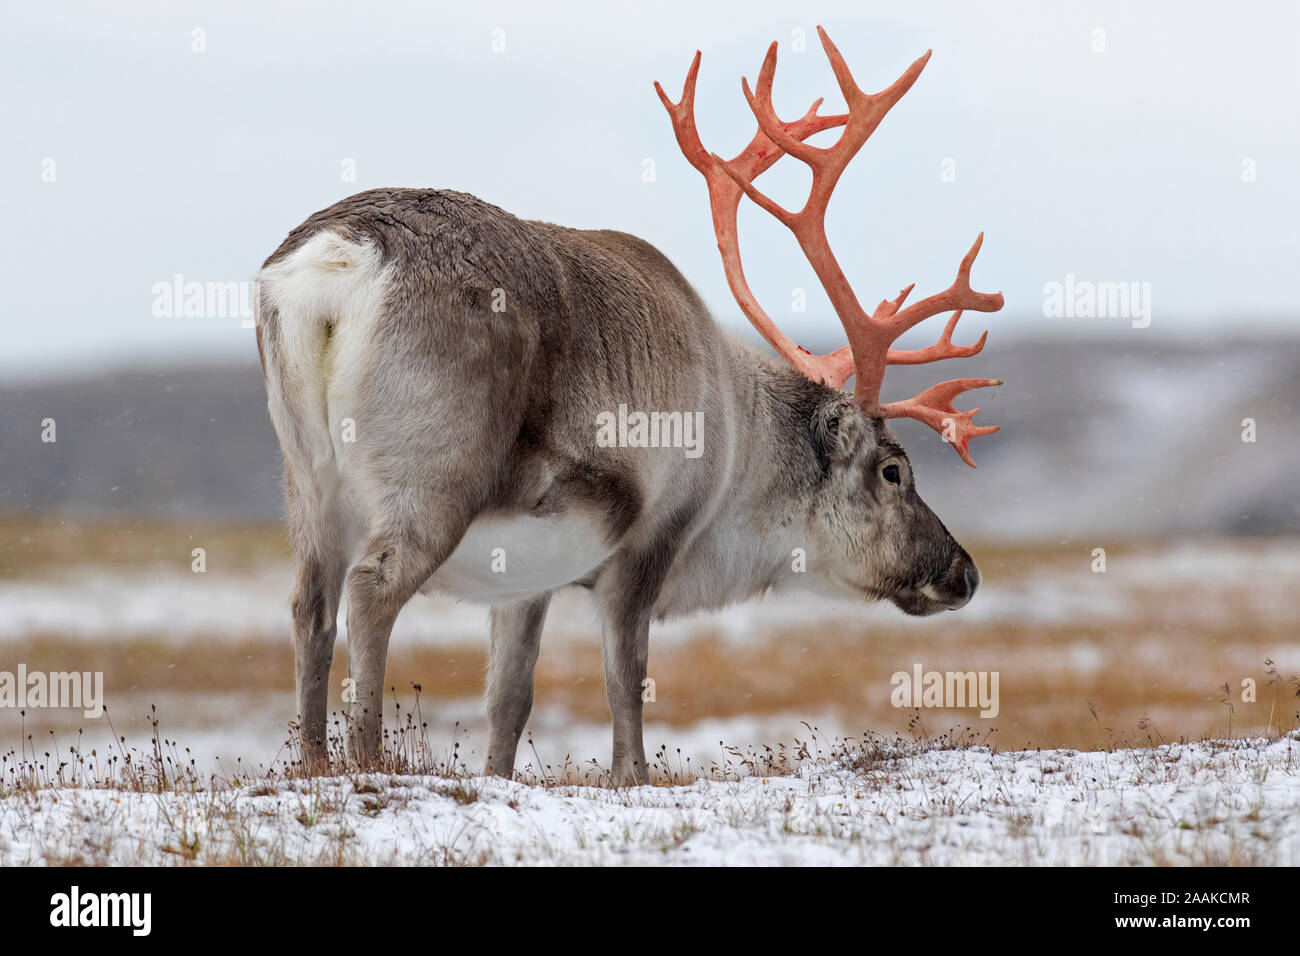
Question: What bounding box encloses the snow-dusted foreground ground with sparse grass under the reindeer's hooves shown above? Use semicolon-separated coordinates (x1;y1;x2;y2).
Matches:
0;734;1300;866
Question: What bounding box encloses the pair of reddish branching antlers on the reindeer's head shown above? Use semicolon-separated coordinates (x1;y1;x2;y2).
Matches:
655;26;1002;467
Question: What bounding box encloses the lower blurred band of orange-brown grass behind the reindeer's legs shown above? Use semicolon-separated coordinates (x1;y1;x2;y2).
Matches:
12;627;1300;749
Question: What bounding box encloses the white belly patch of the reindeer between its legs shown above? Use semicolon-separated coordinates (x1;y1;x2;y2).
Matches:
421;511;614;605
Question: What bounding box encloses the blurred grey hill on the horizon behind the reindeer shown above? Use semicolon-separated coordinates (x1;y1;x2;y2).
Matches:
0;332;1300;538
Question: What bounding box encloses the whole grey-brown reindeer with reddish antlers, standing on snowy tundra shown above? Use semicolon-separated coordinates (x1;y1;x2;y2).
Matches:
256;27;1002;786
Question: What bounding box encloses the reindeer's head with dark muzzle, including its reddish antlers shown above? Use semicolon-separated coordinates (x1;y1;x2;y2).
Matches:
655;26;1002;614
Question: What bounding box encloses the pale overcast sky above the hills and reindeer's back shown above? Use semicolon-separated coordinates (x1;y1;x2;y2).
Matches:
0;0;1300;375
